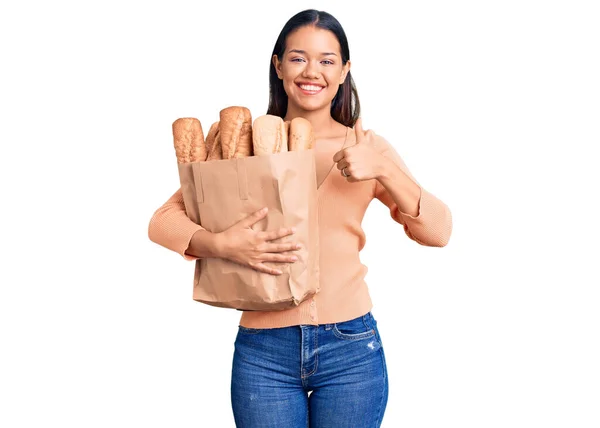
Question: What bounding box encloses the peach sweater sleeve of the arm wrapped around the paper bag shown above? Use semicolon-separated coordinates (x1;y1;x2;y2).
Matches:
148;188;204;260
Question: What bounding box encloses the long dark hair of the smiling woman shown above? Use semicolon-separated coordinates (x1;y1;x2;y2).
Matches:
267;9;360;127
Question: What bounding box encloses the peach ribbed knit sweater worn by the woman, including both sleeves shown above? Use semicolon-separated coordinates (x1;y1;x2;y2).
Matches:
148;128;452;328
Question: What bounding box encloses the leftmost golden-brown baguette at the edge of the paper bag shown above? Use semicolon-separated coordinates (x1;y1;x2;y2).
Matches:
172;117;208;163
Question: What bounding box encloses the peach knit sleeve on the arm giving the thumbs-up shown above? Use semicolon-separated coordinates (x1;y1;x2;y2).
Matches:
375;136;452;247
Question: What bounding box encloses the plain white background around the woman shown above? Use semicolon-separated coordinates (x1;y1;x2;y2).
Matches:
0;0;600;428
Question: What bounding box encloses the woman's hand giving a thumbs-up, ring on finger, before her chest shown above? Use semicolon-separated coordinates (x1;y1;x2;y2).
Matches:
333;118;386;183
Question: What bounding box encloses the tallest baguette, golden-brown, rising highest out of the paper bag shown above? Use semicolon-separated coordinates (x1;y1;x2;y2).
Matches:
219;106;252;159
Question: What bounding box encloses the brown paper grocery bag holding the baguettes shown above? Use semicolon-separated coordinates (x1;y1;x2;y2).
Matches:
178;149;319;311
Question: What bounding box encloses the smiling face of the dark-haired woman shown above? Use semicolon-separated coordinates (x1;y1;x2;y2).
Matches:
273;25;350;112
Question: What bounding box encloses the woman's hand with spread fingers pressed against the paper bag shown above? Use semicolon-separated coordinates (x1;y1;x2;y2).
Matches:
218;208;301;275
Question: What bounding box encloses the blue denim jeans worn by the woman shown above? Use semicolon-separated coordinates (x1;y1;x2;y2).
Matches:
231;312;388;428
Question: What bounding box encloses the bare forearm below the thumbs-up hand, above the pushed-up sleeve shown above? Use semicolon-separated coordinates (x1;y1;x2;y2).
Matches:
377;158;421;217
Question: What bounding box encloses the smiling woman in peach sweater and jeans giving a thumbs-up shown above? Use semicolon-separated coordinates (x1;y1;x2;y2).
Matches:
149;9;452;428
